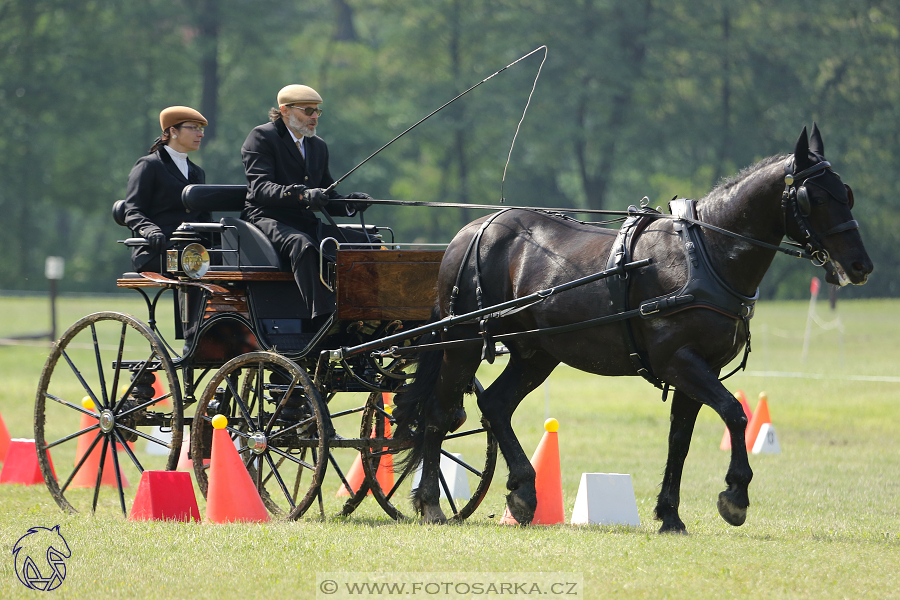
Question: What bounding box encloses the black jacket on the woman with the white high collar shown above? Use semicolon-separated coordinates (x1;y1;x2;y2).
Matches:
125;148;211;271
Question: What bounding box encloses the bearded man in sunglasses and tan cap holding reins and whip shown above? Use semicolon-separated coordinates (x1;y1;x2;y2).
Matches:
241;85;371;329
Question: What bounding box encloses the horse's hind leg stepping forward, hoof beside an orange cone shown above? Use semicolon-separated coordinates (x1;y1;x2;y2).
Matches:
478;351;559;525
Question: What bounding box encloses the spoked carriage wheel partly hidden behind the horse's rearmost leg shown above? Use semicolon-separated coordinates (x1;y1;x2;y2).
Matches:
360;379;497;521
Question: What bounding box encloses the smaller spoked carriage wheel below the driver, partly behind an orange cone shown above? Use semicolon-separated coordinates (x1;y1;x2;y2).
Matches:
191;352;331;519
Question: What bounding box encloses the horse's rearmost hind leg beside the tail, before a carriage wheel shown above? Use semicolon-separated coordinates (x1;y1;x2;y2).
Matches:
412;348;481;523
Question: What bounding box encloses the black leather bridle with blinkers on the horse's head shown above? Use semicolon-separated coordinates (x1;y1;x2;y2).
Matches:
781;157;859;267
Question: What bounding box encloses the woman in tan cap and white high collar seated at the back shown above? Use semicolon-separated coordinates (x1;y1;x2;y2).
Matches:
125;106;211;272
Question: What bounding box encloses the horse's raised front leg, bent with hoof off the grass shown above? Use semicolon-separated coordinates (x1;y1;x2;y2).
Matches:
657;349;753;526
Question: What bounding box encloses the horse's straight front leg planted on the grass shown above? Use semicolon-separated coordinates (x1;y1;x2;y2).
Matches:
655;390;703;533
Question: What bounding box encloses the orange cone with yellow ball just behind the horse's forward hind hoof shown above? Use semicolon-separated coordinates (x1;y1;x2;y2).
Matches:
500;419;566;525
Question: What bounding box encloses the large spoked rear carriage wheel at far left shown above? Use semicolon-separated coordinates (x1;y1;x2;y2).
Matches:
34;312;184;514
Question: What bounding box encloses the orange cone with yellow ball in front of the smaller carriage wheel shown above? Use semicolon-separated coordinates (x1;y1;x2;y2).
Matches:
206;415;269;523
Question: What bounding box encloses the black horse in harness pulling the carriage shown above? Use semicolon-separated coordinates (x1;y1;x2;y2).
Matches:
394;125;873;532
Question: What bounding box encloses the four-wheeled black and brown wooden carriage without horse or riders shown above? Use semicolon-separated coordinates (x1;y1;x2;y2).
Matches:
35;185;497;519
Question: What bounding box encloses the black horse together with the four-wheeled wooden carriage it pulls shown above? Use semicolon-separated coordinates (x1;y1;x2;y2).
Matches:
35;127;873;532
